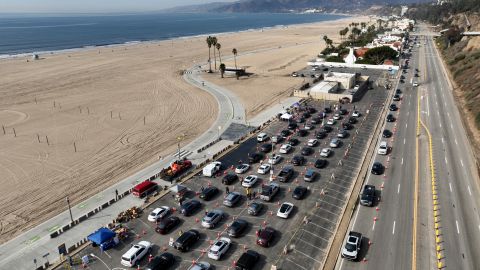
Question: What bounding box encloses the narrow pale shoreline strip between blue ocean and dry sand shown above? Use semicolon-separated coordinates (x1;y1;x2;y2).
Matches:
0;13;352;61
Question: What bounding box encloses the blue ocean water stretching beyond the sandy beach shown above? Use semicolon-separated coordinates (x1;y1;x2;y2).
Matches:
0;13;344;58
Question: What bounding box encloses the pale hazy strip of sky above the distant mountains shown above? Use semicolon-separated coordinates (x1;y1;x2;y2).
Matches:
0;0;235;13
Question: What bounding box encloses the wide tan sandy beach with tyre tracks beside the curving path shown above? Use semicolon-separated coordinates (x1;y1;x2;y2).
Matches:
0;17;368;243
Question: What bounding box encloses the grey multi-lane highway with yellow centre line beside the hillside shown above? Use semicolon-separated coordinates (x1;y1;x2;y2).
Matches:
336;23;480;270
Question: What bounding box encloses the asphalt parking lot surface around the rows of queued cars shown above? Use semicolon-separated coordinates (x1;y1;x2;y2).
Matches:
67;70;388;269
